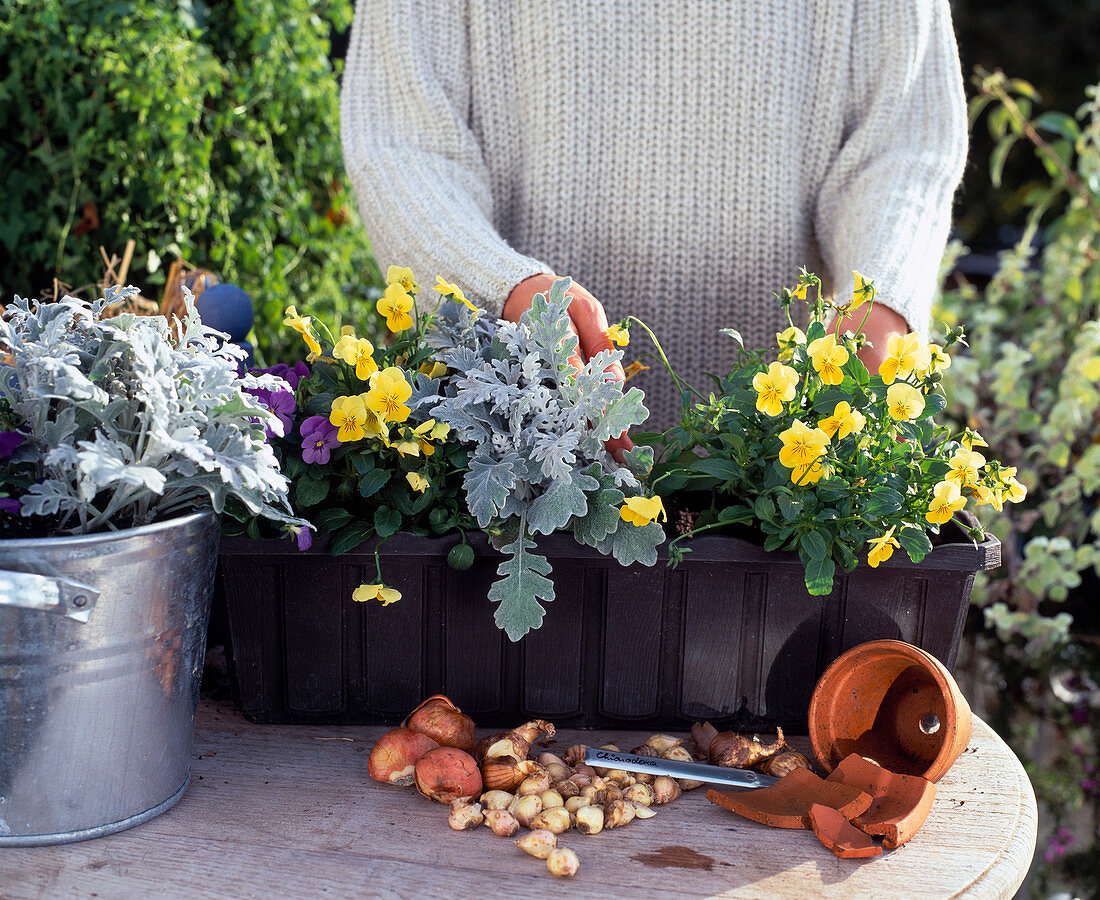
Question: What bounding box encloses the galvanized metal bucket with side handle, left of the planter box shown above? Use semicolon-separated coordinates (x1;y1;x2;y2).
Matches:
0;512;218;848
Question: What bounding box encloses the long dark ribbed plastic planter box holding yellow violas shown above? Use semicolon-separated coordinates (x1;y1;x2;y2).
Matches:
219;533;1000;732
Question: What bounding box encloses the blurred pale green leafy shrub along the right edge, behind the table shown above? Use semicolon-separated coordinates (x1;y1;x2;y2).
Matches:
939;70;1100;896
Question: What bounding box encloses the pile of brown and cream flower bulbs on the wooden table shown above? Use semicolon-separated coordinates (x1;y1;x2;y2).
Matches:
369;694;701;877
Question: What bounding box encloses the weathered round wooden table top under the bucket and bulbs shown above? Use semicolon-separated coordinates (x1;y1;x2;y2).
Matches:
0;701;1036;900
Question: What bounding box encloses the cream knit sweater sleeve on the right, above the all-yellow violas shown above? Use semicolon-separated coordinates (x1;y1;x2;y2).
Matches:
815;0;967;334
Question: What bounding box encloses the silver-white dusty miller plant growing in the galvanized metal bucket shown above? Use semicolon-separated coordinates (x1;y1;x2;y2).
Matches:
0;288;306;534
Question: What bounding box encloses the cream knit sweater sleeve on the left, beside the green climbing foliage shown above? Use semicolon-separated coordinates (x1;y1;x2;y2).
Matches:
341;0;550;315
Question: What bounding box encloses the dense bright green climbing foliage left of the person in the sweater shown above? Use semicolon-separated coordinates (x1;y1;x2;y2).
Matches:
0;0;381;361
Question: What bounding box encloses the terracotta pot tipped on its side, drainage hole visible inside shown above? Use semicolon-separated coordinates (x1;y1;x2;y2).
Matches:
810;640;974;781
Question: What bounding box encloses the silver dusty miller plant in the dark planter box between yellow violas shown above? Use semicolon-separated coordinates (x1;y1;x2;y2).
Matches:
417;278;664;640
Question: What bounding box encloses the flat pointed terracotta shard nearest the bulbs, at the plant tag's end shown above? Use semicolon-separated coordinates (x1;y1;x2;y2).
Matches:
706;768;871;828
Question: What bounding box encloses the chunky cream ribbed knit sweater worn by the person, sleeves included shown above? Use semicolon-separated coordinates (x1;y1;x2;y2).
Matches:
342;0;966;427
